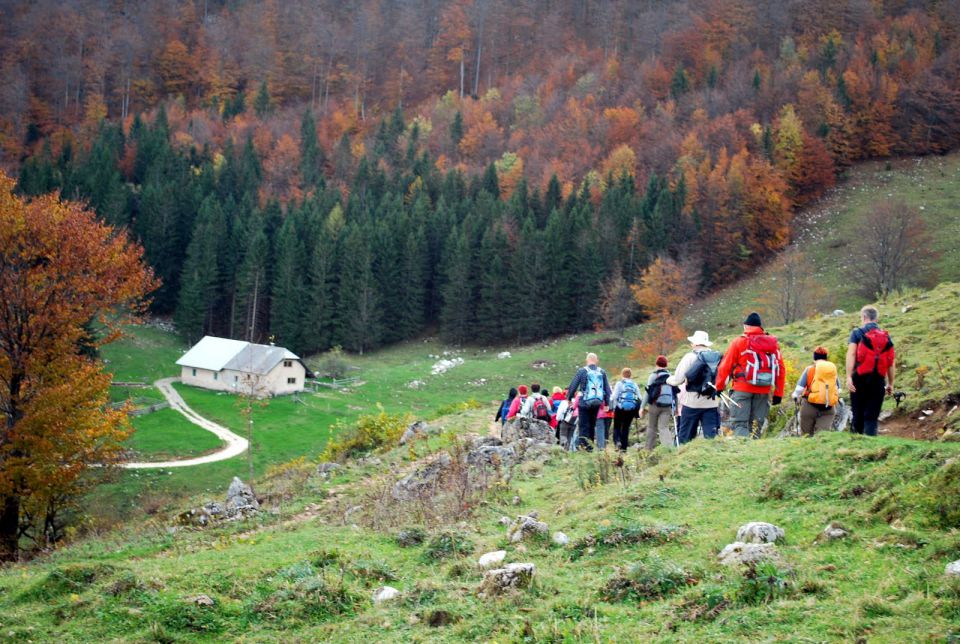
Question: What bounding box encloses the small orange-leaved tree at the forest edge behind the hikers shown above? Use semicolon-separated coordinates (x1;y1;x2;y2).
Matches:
633;257;697;359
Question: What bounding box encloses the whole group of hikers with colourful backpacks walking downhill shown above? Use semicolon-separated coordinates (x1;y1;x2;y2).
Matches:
495;306;896;451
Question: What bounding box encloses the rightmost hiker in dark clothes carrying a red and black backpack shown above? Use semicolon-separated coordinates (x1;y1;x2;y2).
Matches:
847;306;896;436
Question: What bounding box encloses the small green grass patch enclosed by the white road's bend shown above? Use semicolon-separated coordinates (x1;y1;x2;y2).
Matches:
128;407;223;461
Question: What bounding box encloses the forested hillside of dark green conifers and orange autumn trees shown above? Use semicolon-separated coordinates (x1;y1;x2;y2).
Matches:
0;0;960;352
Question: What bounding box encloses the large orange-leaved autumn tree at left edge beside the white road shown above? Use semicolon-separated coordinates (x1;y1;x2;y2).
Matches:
0;173;158;561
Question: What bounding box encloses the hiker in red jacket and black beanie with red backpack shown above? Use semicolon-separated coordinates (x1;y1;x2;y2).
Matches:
717;312;786;438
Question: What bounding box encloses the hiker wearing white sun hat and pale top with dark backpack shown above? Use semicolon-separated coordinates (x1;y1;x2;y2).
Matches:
667;331;722;445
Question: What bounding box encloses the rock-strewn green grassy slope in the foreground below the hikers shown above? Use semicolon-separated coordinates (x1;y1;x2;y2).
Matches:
0;422;960;642
